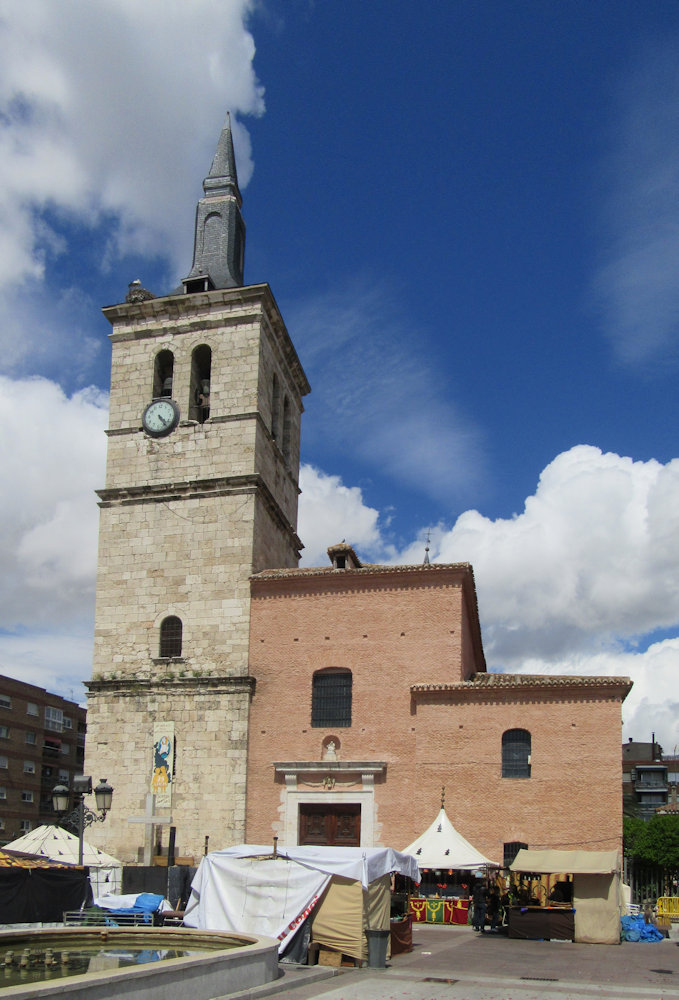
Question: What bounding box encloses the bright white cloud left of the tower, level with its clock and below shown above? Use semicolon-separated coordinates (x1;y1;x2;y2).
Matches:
0;377;108;633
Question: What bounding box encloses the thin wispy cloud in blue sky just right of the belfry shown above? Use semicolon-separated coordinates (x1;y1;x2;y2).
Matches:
290;283;485;503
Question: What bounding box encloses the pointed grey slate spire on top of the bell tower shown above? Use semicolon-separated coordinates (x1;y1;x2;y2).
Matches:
183;112;245;293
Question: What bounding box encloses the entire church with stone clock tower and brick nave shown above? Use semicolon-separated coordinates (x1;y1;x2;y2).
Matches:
85;116;631;864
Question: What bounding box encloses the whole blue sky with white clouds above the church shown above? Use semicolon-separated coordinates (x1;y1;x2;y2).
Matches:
0;0;679;750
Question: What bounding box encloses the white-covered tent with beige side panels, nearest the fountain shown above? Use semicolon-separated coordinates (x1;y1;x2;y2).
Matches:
184;844;420;959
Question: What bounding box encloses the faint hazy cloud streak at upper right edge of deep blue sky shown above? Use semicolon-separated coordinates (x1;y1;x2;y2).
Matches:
595;44;679;363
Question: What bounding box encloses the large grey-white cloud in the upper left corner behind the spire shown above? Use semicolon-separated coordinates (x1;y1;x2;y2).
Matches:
0;0;264;285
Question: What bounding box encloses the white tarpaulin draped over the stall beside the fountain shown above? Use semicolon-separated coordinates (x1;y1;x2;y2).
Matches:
184;844;419;951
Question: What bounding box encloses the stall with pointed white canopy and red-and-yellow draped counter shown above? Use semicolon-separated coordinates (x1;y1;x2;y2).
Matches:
404;796;497;924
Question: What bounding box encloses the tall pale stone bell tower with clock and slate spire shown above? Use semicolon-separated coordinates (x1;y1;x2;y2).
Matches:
86;116;309;862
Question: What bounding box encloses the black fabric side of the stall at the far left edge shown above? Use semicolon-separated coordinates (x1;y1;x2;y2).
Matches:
0;868;92;924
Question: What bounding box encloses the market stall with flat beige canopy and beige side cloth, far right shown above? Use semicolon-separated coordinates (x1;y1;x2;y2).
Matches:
507;850;621;944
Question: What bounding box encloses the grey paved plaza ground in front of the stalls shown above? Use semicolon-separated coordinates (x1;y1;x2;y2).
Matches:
241;925;679;1000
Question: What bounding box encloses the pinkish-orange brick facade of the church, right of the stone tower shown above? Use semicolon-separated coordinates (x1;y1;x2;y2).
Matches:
246;565;630;862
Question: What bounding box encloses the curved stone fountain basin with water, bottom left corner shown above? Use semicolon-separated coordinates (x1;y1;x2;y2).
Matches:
0;927;278;1000
